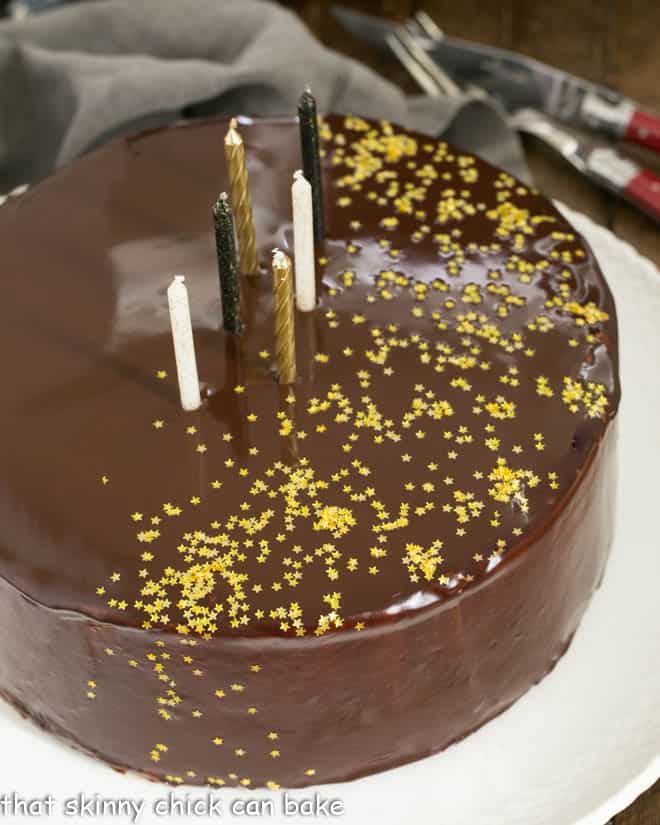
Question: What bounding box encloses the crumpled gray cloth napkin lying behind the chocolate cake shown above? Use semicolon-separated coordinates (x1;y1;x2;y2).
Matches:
0;0;527;192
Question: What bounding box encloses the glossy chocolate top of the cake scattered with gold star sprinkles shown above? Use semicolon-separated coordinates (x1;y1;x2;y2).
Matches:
0;116;619;635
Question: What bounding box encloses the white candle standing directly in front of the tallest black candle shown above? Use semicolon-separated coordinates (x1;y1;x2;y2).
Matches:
291;170;316;312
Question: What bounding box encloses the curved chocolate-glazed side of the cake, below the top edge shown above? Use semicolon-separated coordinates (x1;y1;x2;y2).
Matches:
0;427;616;788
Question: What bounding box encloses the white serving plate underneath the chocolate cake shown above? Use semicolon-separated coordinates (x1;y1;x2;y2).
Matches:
0;201;660;825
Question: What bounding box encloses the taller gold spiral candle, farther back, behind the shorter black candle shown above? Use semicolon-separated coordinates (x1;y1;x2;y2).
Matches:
225;118;259;275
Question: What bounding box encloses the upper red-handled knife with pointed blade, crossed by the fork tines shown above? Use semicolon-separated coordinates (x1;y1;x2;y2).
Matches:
332;5;660;153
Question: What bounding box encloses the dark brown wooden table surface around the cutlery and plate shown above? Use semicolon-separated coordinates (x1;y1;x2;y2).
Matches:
283;0;660;825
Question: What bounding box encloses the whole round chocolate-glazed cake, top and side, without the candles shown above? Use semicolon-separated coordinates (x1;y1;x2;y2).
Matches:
0;116;619;788
